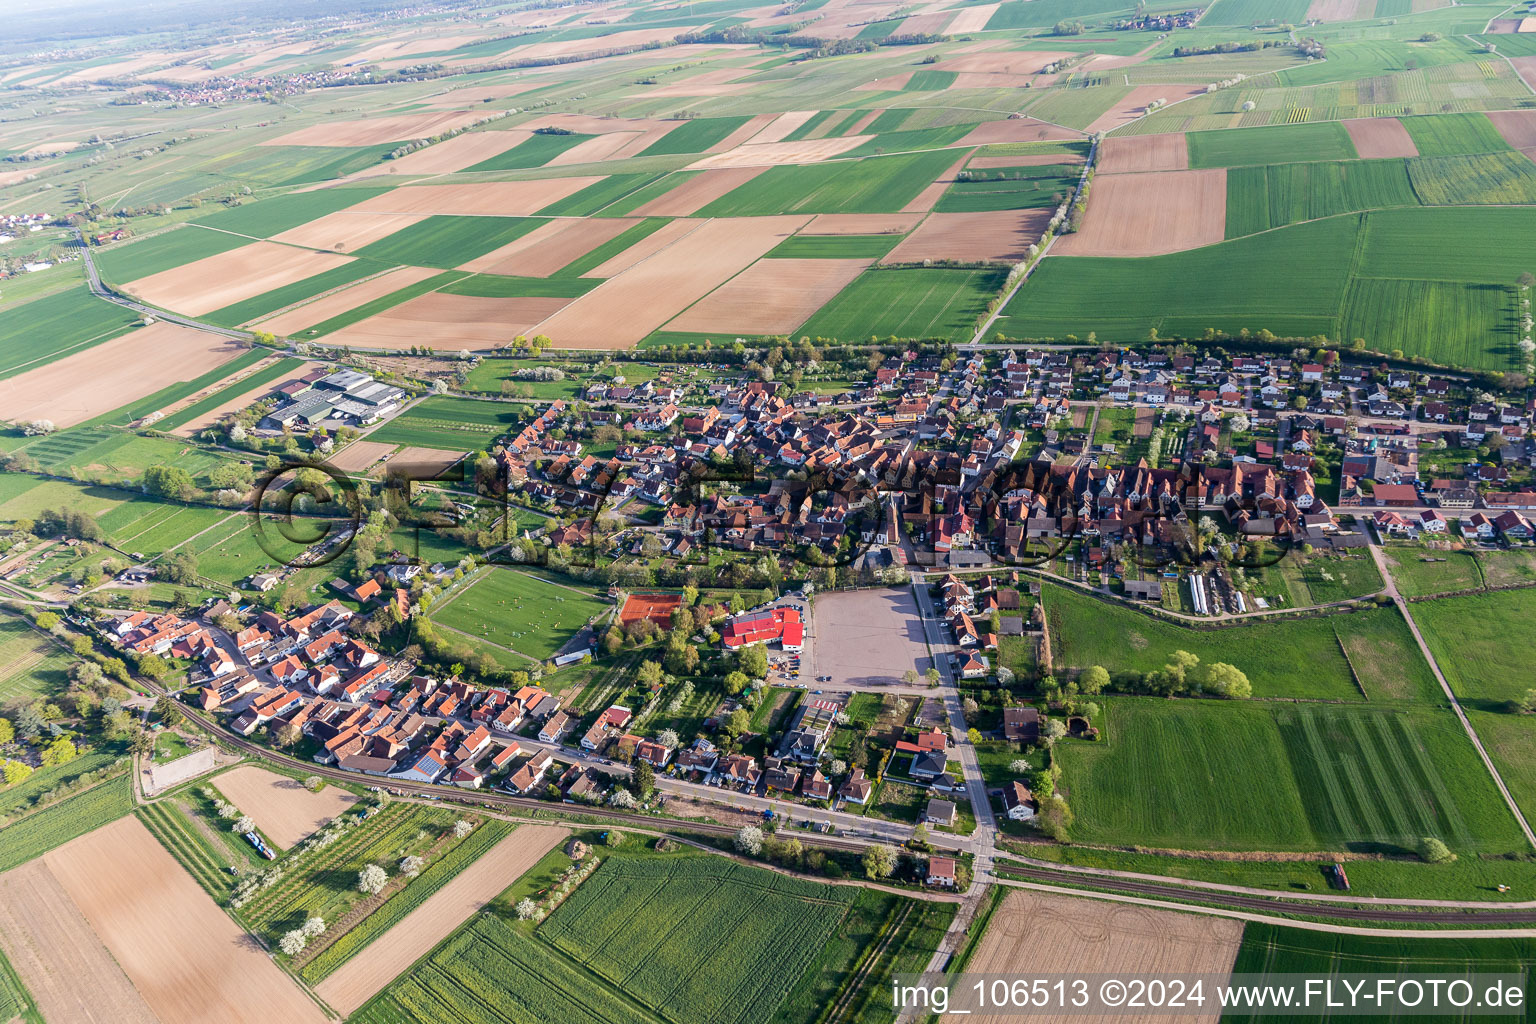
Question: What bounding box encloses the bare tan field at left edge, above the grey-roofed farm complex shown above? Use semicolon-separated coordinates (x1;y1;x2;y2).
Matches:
0;322;246;427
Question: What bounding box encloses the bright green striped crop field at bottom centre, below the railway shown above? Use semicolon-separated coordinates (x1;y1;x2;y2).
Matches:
539;857;854;1024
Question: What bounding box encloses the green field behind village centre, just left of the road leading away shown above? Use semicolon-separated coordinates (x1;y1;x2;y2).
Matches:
794;267;1006;341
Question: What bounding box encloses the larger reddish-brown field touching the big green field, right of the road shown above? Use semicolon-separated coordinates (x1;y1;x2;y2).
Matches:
1055;169;1227;256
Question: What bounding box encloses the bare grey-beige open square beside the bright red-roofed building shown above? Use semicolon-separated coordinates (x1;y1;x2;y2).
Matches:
813;586;931;689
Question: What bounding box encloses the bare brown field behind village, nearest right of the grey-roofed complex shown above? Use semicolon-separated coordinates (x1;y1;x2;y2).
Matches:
327;292;577;348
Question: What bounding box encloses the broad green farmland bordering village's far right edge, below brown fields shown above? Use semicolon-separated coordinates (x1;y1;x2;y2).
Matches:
992;207;1536;370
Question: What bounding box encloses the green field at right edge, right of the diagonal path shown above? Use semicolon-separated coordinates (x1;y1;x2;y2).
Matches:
1410;590;1536;703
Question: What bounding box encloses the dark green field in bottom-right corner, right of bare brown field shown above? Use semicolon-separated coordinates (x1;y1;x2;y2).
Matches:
1221;927;1536;1024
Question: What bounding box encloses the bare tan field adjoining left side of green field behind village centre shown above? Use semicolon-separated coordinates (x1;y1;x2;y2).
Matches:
667;259;872;335
